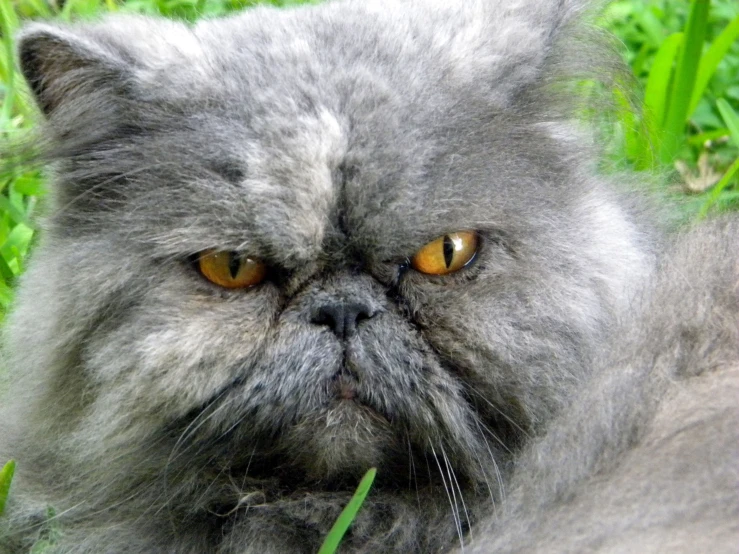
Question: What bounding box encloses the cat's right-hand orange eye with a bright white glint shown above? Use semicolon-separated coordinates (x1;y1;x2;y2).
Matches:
411;231;478;275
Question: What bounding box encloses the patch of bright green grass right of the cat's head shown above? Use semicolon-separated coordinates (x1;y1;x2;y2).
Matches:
604;0;739;213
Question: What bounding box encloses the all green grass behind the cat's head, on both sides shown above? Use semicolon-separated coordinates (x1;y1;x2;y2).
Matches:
0;0;739;324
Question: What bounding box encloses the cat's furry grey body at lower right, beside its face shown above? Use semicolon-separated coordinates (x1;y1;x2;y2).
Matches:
471;217;739;553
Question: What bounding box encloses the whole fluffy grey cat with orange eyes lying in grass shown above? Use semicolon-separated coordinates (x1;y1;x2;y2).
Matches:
0;0;739;554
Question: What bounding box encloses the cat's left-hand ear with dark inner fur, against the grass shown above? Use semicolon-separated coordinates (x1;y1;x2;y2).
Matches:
18;16;194;117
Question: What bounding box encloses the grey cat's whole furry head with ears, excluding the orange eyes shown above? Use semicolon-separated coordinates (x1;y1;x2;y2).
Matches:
8;2;652;544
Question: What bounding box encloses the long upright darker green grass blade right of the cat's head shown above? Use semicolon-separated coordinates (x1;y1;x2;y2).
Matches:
660;0;710;164
